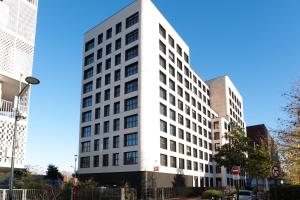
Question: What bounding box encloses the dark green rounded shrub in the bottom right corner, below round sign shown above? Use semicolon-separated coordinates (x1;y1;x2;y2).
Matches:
270;185;300;200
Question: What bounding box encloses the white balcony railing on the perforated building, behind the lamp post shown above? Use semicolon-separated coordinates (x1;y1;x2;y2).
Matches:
0;99;27;118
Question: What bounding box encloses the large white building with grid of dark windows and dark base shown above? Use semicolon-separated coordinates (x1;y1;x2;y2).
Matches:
79;0;242;187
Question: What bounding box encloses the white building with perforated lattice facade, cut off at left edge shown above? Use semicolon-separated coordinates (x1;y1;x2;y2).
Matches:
0;0;38;168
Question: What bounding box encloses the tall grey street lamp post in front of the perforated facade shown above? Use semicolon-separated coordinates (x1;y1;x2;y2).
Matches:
9;76;40;200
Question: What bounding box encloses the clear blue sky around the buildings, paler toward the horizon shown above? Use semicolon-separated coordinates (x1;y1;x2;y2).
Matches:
27;0;300;171
